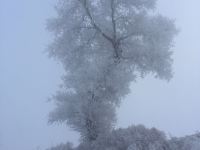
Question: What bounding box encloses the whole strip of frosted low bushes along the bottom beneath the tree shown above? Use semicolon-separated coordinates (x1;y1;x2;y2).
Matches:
48;125;200;150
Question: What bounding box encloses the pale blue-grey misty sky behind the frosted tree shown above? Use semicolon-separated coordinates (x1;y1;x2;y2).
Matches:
0;0;200;150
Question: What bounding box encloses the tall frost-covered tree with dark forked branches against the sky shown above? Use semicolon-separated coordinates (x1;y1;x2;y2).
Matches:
48;0;177;141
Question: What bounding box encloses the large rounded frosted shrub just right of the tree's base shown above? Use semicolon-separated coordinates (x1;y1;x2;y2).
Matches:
93;125;169;150
